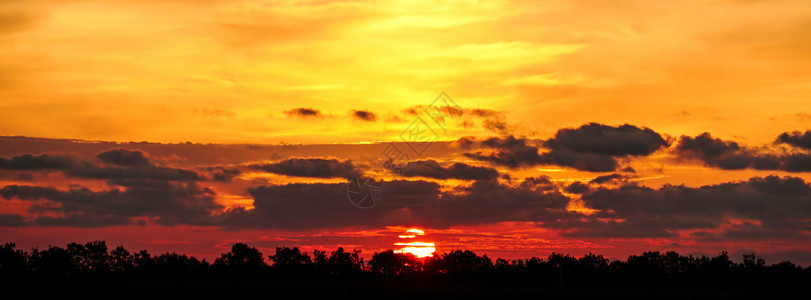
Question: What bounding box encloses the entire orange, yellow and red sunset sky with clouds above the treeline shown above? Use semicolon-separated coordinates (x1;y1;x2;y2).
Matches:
0;0;811;264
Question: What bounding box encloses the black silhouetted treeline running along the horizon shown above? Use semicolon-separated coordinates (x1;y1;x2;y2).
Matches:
0;241;811;289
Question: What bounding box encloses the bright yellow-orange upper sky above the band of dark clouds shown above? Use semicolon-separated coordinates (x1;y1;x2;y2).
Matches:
0;0;811;143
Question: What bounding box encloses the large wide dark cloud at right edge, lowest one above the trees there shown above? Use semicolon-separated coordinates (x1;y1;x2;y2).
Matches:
550;176;811;238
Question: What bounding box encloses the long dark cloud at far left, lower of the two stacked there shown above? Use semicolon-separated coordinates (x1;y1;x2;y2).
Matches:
0;180;222;227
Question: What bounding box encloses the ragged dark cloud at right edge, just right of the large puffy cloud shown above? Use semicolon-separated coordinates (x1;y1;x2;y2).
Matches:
675;132;811;172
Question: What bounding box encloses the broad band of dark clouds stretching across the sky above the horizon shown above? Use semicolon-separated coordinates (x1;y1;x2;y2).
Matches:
0;123;811;241
